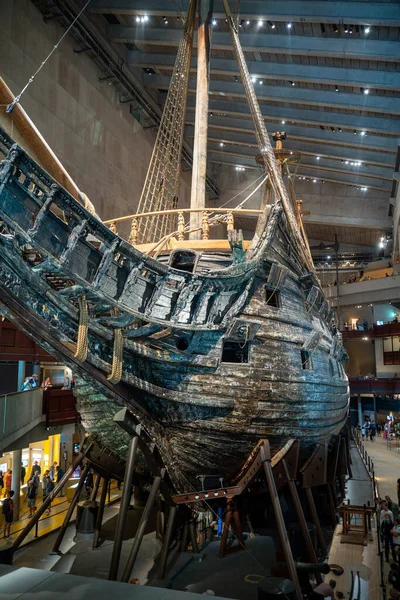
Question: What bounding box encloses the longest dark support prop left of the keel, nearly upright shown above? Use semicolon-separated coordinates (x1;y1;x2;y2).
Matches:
108;426;140;581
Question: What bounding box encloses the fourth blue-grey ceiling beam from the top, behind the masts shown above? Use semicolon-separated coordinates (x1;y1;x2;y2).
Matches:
142;73;400;120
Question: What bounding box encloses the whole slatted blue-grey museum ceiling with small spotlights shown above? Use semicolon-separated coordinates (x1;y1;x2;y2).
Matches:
34;0;400;251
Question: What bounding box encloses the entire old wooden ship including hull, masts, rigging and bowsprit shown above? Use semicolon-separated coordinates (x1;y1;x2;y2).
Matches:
0;0;349;494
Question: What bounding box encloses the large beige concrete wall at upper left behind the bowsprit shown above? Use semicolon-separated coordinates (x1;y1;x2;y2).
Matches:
0;0;191;226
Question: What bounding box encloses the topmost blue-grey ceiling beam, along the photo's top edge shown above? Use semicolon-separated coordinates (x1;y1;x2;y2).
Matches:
89;0;400;27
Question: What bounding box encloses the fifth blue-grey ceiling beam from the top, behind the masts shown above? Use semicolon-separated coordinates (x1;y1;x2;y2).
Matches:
183;93;400;137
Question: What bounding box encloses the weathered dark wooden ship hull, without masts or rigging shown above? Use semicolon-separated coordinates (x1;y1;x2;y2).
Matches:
0;126;349;492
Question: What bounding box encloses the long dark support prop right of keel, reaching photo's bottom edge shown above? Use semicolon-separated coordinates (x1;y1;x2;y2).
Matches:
260;440;303;600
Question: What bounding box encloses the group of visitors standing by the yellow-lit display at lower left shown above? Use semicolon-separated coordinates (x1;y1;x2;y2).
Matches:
0;460;64;537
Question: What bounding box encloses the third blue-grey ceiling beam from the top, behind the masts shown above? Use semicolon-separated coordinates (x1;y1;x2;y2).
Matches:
127;51;400;91
